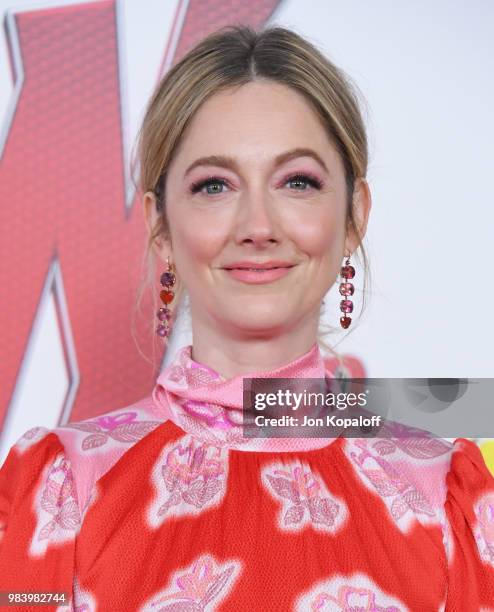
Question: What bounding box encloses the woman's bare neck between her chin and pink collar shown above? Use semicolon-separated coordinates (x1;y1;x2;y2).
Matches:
191;320;317;379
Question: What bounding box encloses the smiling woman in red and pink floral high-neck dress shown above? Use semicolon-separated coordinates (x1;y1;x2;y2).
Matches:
0;27;494;612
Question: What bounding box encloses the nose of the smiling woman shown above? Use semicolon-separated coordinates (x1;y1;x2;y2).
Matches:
236;188;280;246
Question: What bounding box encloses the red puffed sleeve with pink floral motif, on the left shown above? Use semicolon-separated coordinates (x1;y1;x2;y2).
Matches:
0;427;80;611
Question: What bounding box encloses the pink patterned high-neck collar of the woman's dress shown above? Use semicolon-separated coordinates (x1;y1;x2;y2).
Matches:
153;343;342;452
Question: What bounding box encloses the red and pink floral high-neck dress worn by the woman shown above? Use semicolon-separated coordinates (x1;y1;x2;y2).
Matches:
0;344;494;612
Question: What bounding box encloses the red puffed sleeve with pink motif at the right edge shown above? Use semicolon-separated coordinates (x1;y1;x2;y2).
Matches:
445;438;494;611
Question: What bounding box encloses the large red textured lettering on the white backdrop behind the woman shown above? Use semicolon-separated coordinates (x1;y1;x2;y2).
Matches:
0;0;286;427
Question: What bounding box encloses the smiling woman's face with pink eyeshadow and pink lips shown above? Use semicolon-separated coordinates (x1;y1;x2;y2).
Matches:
146;80;370;338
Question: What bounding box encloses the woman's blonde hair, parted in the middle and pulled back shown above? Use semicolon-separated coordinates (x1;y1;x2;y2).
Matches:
132;25;370;364
